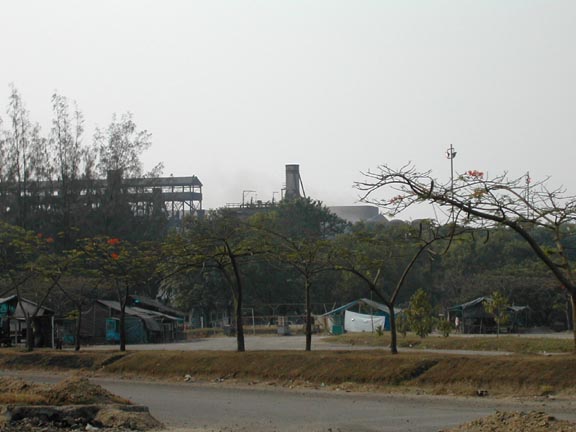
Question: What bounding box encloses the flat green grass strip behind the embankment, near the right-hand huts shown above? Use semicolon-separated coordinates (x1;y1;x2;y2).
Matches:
324;333;574;354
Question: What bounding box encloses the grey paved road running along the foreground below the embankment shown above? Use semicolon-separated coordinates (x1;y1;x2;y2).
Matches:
0;371;576;432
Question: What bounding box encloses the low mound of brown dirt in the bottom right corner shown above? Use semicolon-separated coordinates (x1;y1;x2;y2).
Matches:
443;411;576;432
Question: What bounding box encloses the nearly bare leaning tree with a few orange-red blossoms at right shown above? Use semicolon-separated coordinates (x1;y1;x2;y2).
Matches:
355;165;576;348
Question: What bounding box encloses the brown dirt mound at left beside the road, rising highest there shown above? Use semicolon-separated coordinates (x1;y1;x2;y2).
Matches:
46;377;130;405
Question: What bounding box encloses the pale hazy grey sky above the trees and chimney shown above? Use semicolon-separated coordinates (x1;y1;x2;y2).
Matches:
0;0;576;218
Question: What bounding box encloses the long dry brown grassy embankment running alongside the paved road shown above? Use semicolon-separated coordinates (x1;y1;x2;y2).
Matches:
0;350;576;396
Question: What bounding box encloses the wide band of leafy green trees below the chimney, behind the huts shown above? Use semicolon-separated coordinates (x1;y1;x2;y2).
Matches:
0;193;565;352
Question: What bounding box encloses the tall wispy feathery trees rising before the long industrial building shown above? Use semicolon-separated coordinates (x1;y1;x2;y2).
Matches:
0;86;162;241
